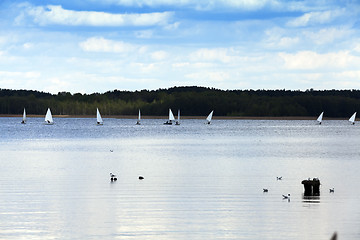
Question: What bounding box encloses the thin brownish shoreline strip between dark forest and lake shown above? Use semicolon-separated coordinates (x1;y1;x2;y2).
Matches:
0;114;347;121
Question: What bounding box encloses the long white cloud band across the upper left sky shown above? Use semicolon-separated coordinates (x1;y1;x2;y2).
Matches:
20;5;173;26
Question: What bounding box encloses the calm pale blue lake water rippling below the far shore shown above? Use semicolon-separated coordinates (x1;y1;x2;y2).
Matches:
0;118;360;240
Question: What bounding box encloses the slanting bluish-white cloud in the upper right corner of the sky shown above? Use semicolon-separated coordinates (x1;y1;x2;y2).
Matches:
287;9;346;27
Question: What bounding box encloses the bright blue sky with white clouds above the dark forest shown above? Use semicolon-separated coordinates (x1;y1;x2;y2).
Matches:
0;0;360;94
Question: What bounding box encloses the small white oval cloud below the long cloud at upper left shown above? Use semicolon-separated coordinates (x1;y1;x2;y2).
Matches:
79;37;138;53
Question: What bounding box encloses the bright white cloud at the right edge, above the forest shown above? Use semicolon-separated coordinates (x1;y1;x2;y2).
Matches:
279;51;360;70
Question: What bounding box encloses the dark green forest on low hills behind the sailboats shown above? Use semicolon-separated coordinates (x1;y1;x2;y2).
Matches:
0;86;360;118
